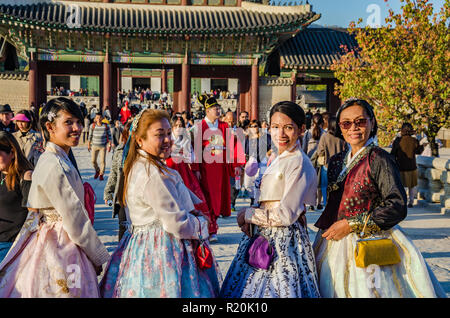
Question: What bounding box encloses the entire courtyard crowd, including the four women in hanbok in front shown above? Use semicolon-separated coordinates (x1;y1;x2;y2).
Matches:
0;95;445;298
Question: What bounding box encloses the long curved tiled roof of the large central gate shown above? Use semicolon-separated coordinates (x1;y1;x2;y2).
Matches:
0;1;320;35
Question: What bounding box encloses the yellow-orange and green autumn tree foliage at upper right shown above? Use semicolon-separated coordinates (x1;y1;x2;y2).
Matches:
332;0;450;155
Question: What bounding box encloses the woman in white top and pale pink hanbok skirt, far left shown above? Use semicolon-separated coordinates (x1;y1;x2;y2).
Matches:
0;97;109;298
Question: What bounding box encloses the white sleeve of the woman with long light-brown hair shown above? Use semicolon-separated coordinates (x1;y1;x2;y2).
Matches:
143;172;200;239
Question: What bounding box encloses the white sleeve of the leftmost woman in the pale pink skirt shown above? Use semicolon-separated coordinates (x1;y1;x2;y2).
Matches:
38;165;109;266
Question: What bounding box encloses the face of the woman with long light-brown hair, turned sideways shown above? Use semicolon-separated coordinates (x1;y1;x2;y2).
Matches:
136;118;173;159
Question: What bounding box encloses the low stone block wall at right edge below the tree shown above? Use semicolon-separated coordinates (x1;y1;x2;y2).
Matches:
417;156;450;214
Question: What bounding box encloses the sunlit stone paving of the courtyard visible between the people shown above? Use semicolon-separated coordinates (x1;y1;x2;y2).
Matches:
74;146;450;297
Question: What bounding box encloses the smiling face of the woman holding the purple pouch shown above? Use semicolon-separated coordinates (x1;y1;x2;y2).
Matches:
270;112;301;154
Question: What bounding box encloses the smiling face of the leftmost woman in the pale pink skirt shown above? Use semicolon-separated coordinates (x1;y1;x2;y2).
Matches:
45;110;83;153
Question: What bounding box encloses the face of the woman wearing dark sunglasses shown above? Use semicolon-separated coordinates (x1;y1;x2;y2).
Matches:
339;105;374;153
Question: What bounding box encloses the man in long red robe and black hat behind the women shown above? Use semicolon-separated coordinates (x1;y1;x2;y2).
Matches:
192;95;245;242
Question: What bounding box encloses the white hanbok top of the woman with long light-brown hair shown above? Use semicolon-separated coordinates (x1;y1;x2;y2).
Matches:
125;150;204;239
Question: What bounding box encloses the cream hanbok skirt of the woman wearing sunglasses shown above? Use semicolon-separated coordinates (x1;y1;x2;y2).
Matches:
313;226;446;298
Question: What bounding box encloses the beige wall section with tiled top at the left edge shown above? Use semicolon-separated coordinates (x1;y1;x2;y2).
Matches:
0;72;30;112
